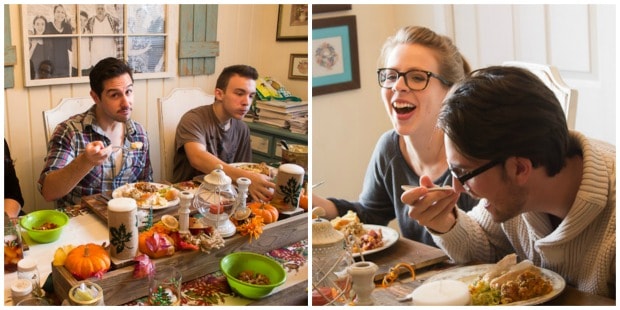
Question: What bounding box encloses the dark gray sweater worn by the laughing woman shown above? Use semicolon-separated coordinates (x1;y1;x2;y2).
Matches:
329;130;477;246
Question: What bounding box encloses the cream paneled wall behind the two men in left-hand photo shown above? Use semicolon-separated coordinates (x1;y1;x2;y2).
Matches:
3;4;308;211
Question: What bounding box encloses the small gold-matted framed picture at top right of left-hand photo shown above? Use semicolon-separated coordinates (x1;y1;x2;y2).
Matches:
276;4;308;41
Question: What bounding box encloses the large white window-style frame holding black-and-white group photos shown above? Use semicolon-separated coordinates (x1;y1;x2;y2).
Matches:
21;4;176;87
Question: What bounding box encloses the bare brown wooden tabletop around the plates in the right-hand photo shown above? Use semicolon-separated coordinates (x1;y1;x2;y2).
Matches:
356;237;616;306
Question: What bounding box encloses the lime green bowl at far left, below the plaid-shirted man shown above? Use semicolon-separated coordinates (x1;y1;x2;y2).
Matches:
19;210;69;243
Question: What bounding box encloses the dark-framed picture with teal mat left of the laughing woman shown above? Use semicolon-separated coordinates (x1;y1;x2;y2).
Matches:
312;16;360;96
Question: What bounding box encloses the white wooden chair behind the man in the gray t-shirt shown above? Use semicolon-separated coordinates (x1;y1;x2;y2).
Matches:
157;88;215;180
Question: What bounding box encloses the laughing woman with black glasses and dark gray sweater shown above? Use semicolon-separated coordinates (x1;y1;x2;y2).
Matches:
312;26;475;246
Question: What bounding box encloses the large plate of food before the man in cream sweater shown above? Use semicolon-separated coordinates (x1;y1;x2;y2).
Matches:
426;254;566;306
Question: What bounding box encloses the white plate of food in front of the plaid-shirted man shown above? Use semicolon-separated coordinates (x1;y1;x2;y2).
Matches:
112;182;181;210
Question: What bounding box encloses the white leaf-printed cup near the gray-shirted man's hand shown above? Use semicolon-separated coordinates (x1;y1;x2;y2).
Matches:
271;164;305;212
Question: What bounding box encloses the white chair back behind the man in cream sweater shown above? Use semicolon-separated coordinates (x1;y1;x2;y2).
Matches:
502;61;577;129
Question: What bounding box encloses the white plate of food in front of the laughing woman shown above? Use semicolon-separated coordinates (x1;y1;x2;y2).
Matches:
352;224;400;257
